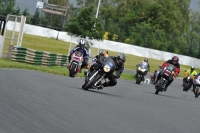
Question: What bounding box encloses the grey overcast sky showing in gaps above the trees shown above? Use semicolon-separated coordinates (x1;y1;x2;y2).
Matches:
16;0;199;14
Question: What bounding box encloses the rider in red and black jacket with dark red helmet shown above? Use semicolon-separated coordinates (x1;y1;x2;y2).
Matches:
153;56;180;91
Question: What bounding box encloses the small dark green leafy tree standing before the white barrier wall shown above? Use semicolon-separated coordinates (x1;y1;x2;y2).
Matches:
66;6;103;40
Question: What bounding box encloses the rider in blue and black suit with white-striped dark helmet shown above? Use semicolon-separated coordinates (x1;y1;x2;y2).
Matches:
68;39;89;72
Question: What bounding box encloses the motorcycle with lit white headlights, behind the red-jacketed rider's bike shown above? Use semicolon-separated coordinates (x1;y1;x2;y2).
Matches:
135;62;148;84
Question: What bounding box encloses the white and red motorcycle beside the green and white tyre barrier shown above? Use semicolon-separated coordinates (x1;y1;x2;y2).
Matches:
68;51;83;77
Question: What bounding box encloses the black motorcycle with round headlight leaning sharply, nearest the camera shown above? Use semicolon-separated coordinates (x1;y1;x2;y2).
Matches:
82;57;116;90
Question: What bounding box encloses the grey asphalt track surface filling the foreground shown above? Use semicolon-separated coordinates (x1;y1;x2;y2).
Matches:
0;69;200;133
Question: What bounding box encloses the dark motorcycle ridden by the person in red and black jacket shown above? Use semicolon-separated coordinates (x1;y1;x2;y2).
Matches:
155;64;176;94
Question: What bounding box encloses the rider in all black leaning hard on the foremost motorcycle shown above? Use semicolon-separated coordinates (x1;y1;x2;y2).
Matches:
90;53;126;89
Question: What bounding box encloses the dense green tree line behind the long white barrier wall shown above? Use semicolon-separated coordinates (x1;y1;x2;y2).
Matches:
0;0;200;58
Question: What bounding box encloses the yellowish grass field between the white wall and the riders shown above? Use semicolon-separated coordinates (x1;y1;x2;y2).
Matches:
3;31;200;77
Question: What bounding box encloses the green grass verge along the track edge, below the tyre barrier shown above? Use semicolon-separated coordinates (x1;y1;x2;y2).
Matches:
0;59;135;81
